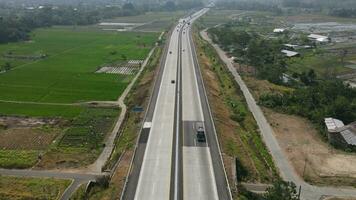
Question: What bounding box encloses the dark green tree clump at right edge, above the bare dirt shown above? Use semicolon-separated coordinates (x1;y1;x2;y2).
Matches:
260;80;356;137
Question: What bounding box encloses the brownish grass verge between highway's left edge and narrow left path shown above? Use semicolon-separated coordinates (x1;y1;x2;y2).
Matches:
71;38;163;200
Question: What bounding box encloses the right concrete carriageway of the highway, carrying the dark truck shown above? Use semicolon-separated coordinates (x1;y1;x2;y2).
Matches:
182;11;219;200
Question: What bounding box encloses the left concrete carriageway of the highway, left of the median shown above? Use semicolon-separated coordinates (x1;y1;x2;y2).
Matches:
135;25;179;200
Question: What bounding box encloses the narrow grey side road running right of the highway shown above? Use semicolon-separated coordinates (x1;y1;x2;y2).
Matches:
200;30;356;200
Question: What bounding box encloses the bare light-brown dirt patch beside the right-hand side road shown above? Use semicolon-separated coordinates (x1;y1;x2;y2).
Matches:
263;108;356;185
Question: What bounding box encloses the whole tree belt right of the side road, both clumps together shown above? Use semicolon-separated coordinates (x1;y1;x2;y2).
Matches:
208;24;356;141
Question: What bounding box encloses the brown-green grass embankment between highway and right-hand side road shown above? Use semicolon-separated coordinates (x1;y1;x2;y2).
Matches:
194;27;278;190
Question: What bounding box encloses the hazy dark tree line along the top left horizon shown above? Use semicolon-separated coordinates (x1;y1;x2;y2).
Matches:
0;1;203;43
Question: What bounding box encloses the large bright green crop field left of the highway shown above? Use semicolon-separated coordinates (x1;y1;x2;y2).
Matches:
0;27;157;118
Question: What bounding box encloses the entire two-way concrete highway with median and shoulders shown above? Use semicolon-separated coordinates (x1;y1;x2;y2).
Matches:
121;8;231;200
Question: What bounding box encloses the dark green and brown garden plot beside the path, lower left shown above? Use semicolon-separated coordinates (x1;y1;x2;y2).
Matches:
37;108;120;168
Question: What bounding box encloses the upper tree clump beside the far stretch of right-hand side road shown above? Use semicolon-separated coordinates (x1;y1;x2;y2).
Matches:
208;25;286;84
